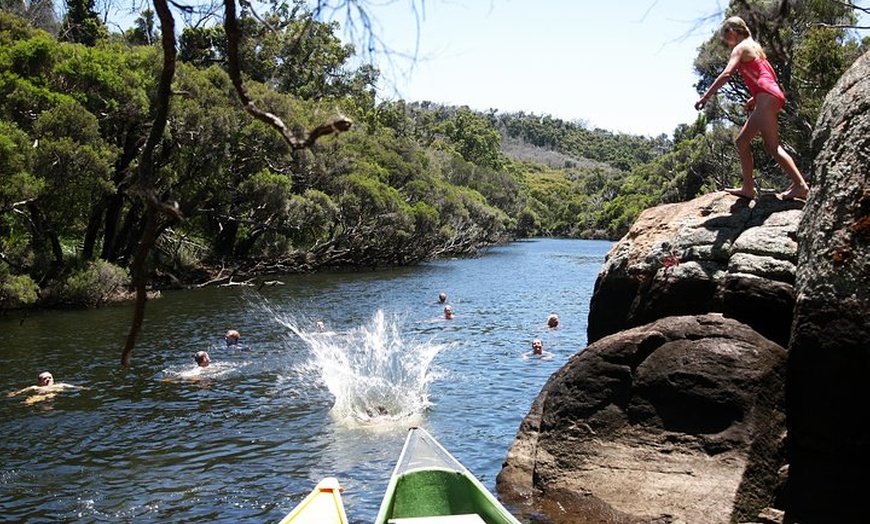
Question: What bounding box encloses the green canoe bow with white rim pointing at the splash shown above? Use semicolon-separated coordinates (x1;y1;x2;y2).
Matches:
375;428;520;524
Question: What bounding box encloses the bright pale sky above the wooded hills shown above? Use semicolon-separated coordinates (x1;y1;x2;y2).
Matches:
328;0;870;136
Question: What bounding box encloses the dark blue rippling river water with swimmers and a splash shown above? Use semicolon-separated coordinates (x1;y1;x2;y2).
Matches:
0;239;611;523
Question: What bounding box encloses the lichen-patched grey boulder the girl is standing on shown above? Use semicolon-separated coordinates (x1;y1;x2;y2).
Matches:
587;192;803;346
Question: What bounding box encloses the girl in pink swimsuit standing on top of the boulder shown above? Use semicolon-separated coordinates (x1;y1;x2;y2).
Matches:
695;16;809;200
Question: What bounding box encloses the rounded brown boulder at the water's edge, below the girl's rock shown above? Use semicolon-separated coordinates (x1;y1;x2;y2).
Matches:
497;314;786;524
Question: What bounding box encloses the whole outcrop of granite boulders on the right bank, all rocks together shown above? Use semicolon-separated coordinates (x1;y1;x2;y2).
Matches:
497;50;870;524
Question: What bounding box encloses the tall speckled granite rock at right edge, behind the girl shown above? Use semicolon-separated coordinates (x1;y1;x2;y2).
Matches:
786;53;870;524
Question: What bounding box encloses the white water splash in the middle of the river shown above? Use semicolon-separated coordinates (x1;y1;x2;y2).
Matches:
283;310;446;425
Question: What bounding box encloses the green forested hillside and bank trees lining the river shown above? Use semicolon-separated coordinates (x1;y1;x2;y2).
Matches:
0;0;861;310
